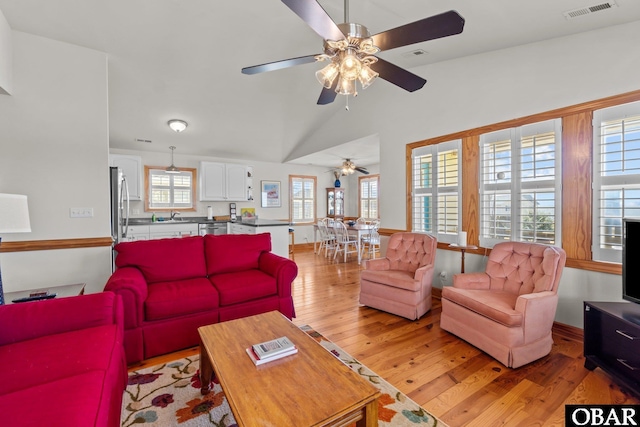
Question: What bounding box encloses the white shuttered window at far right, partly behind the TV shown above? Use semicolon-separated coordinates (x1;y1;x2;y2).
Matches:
592;102;640;262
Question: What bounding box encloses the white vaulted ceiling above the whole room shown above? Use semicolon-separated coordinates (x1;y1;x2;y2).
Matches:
0;0;640;166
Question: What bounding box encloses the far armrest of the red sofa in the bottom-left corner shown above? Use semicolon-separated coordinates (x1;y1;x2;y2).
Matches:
0;292;123;345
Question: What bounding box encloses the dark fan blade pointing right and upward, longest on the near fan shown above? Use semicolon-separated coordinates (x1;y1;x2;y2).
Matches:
372;10;464;51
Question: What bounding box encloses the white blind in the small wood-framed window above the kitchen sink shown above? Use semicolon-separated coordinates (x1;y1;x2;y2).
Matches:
149;169;194;209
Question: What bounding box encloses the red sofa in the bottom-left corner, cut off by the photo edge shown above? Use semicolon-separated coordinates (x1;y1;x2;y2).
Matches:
0;292;127;427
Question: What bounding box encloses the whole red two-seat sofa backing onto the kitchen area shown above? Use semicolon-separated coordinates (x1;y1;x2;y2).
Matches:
105;233;298;363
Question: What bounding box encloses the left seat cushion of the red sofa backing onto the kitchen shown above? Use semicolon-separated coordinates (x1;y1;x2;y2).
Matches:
144;277;219;321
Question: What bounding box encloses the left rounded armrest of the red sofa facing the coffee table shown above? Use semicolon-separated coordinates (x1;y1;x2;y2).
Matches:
104;267;148;329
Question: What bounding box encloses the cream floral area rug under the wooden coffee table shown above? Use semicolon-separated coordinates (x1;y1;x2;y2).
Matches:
121;326;446;427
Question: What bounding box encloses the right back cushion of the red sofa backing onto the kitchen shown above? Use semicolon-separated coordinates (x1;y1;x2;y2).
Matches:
204;233;271;276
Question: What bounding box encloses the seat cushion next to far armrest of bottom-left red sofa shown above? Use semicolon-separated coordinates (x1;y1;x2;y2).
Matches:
0;326;124;396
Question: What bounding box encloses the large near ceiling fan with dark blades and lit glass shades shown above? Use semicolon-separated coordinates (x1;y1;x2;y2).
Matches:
242;0;464;105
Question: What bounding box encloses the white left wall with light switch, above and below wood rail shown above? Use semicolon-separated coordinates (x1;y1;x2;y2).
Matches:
0;31;111;292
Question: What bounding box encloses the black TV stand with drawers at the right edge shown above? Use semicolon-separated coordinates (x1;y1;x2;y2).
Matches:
584;301;640;399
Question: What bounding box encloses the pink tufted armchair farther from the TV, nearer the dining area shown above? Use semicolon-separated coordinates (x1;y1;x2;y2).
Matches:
360;233;437;320
